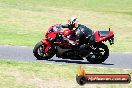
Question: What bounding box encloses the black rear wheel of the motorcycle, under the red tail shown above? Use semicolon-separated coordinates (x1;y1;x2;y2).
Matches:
86;43;109;64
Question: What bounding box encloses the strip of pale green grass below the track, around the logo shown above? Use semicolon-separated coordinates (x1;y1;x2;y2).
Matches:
0;60;132;88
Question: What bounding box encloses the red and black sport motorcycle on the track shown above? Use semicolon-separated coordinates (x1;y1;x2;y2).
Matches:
33;24;114;64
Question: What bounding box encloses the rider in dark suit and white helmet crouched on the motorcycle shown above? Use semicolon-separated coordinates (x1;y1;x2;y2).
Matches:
62;17;95;47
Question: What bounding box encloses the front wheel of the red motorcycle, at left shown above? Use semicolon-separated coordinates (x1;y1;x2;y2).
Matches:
33;42;55;60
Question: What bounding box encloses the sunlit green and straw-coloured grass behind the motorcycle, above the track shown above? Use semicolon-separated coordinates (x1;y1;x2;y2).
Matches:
0;0;132;52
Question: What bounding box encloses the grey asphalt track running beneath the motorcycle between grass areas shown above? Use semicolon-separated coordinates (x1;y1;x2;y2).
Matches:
0;46;132;69
